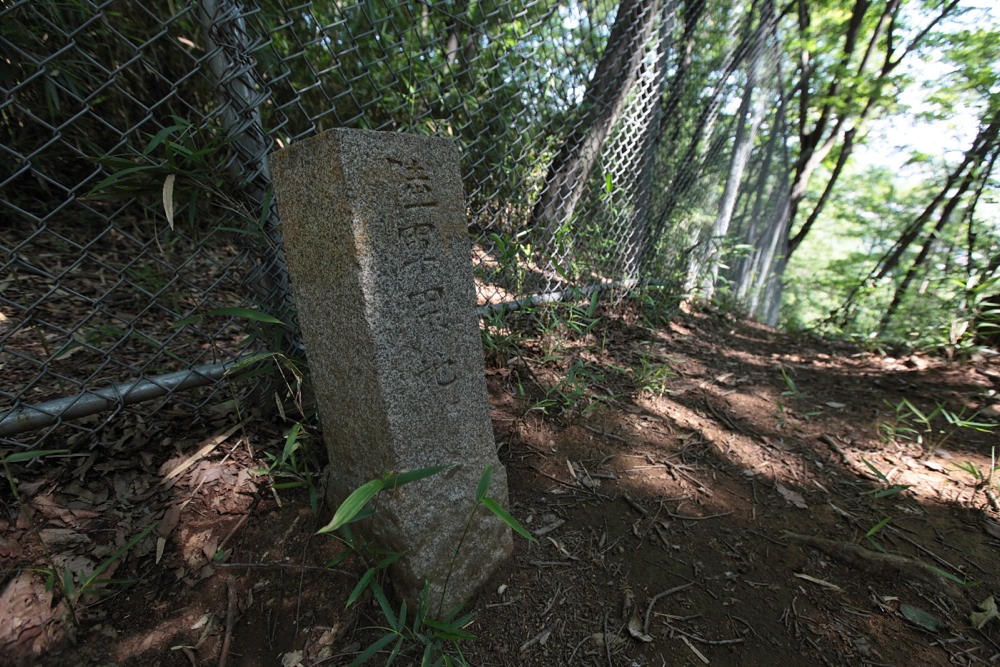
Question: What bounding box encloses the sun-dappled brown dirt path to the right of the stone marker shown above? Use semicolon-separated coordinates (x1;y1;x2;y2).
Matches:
470;306;1000;665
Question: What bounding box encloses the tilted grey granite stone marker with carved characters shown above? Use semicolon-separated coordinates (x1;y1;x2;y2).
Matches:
271;130;511;612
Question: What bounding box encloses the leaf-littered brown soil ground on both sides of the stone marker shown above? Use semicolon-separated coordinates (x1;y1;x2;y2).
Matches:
0;309;1000;667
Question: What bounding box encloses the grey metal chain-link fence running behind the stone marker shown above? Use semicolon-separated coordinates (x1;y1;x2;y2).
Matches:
0;0;788;444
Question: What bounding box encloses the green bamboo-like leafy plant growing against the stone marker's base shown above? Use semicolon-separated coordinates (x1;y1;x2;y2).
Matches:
317;465;537;667
